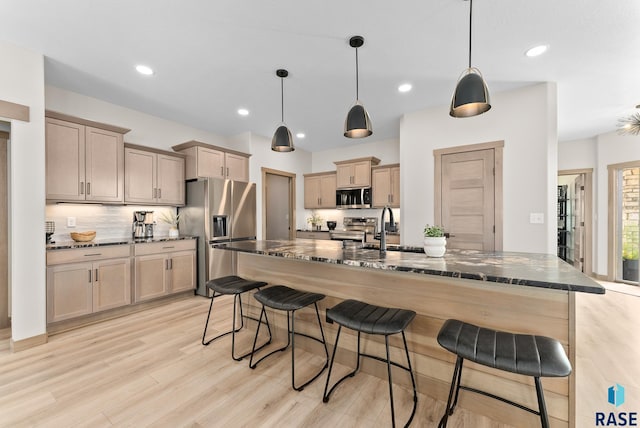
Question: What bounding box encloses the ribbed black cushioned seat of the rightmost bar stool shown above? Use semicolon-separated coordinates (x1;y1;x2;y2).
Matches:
438;319;571;377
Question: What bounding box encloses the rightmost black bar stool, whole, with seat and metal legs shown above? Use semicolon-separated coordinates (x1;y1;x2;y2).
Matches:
438;319;571;428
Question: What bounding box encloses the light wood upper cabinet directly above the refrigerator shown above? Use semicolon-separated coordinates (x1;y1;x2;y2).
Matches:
172;140;251;181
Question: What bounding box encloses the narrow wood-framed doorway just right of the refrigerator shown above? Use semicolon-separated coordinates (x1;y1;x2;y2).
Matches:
262;168;296;240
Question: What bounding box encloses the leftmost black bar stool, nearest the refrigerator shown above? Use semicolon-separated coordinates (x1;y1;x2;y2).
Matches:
202;275;271;361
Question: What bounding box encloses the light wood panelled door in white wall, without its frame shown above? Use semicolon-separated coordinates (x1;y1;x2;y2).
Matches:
441;149;495;251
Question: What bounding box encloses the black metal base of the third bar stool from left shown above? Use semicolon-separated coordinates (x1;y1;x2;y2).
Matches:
322;325;418;427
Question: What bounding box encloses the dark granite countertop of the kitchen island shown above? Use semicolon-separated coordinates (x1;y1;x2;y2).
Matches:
214;239;605;294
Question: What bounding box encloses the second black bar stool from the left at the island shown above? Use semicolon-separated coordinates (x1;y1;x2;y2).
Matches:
249;285;329;391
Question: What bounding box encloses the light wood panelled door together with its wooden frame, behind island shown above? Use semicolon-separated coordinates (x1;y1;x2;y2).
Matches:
434;141;504;251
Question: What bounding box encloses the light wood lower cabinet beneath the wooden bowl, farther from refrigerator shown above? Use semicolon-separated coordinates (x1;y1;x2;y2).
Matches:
47;258;131;322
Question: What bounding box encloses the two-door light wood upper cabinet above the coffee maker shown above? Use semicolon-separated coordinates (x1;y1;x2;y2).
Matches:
124;144;185;206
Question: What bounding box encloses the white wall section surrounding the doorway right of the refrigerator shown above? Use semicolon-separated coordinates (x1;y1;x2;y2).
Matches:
242;133;311;239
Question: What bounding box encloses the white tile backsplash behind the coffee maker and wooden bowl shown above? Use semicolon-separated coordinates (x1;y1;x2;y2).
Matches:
46;204;176;241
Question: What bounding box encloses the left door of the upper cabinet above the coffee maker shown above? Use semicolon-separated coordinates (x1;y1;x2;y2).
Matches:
124;148;157;204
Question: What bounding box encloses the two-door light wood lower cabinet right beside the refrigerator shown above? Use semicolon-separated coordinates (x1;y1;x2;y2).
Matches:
134;240;196;302
